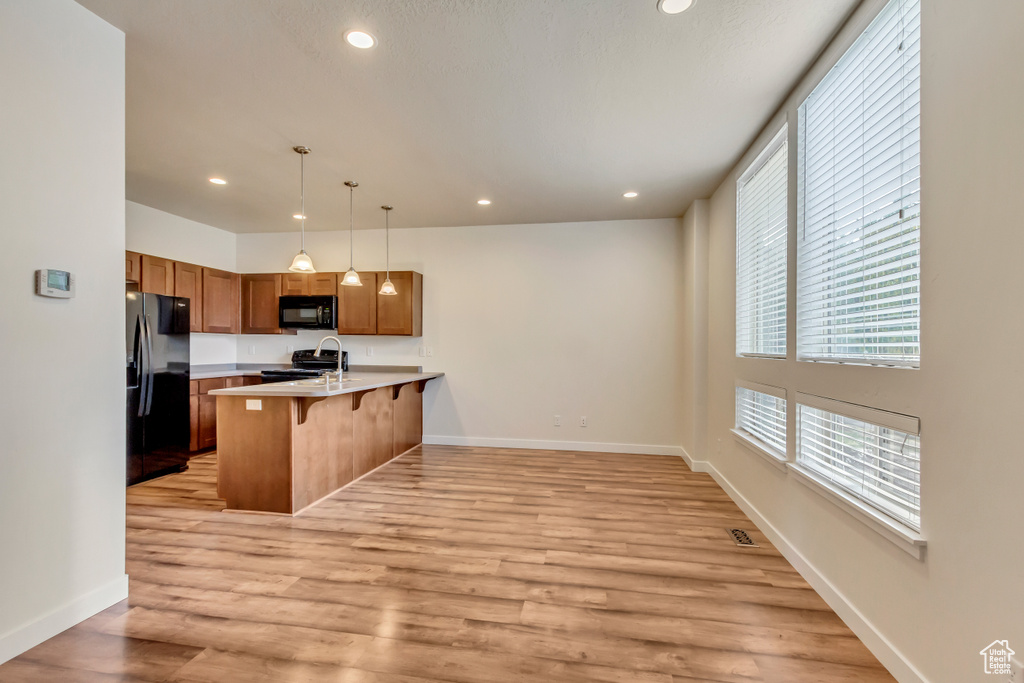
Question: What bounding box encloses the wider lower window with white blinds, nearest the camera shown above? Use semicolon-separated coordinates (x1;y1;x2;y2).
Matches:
797;394;921;530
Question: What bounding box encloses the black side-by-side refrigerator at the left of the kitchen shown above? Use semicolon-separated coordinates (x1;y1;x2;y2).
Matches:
125;292;190;485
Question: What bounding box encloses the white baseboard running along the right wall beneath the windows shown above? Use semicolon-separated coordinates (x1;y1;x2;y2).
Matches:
696;456;928;683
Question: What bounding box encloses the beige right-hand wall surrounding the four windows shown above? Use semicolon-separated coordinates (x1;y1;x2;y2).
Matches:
692;0;1024;683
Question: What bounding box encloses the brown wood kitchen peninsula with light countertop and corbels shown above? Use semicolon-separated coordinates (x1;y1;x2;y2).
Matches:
210;372;443;515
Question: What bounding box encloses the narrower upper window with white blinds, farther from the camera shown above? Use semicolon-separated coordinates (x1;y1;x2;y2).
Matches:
736;127;790;357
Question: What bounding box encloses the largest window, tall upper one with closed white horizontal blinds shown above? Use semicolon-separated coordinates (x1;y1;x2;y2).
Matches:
797;0;921;367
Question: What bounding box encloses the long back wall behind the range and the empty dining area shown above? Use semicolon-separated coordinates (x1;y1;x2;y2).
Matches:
238;219;681;454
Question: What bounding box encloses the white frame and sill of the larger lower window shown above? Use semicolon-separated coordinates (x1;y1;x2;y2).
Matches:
788;391;928;559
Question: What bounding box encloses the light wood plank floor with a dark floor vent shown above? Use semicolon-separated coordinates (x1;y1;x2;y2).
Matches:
0;446;893;683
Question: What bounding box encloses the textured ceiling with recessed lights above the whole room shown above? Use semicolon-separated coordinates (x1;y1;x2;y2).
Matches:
79;0;857;232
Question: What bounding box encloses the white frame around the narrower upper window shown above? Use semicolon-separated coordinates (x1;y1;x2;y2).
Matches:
735;123;790;358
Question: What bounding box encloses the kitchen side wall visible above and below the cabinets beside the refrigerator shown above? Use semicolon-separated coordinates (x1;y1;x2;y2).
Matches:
125;202;238;366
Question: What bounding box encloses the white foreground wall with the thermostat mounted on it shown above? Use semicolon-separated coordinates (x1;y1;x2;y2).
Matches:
0;0;128;661
